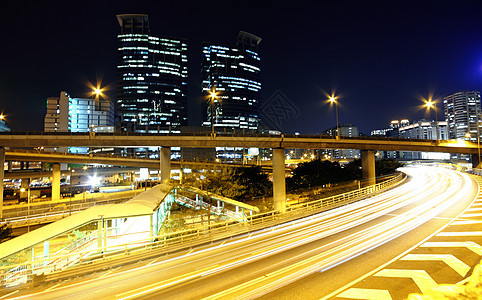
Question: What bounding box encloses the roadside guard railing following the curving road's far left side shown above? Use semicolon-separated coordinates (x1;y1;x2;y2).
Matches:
0;173;406;287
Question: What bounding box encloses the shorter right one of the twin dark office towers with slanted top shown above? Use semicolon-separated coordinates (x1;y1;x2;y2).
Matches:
201;31;261;132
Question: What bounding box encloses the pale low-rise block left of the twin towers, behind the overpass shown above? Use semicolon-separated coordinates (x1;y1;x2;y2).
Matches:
44;91;114;153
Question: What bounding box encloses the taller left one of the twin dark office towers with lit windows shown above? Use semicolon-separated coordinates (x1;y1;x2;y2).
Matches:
117;14;187;133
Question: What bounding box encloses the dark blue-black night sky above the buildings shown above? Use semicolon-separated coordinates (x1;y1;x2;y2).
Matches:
0;1;482;134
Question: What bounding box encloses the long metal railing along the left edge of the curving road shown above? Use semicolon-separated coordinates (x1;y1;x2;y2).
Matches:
0;173;405;286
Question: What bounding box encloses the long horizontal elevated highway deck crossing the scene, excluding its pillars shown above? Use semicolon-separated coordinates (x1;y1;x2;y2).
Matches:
0;132;478;154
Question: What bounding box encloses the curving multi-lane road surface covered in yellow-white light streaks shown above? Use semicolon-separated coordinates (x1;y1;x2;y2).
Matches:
4;167;478;299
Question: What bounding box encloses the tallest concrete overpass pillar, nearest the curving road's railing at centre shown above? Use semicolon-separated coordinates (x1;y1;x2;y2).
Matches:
273;148;286;213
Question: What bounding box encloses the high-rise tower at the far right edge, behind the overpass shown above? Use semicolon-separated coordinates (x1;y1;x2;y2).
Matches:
444;90;482;141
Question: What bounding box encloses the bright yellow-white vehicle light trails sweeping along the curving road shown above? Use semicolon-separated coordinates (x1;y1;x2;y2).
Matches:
10;167;473;299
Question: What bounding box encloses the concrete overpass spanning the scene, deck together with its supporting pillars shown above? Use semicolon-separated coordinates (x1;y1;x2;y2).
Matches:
0;132;480;214
